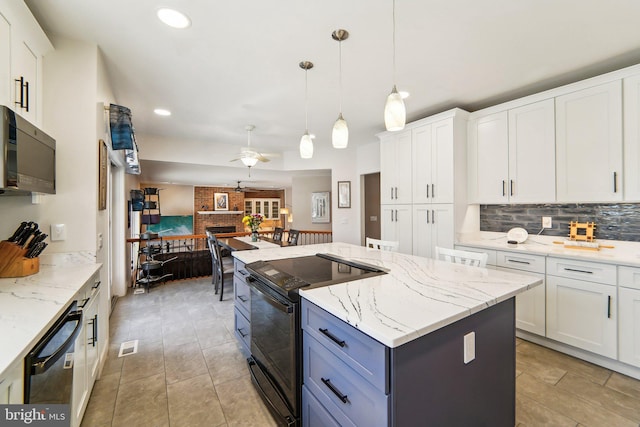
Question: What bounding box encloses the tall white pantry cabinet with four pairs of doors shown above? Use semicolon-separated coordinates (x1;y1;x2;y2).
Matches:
378;108;468;257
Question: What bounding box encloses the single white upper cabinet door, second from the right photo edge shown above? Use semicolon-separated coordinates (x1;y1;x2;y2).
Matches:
556;81;622;206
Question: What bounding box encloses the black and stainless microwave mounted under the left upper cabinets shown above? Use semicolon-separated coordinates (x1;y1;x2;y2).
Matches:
0;105;56;195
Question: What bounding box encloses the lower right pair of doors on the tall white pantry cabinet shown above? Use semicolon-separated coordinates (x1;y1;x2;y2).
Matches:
413;203;454;258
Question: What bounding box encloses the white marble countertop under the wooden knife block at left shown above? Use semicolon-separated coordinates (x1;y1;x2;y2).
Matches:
0;252;102;376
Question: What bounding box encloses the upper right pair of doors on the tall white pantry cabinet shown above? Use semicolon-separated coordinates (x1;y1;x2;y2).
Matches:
413;118;454;203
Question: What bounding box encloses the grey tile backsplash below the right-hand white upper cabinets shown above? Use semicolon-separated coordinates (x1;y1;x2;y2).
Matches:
480;203;640;242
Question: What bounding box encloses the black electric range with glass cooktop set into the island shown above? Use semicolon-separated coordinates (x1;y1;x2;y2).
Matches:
245;254;385;426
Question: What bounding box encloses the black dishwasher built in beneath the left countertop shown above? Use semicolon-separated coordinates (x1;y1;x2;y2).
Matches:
24;301;82;404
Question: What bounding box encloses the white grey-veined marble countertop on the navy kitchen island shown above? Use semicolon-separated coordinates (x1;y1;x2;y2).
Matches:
233;243;542;348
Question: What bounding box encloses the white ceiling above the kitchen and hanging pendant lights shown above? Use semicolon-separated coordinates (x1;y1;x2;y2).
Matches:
26;0;640;186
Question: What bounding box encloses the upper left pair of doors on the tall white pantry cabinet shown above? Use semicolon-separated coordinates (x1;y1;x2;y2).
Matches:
380;131;411;205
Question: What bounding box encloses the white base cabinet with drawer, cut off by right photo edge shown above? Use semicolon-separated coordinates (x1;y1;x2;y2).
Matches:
618;267;640;367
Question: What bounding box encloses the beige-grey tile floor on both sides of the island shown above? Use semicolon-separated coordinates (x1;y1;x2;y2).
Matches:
82;278;640;427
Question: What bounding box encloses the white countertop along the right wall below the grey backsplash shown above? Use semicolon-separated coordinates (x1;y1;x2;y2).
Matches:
456;231;640;267
